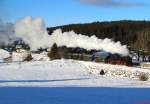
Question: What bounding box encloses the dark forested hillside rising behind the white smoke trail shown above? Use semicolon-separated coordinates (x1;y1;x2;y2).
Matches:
47;20;150;52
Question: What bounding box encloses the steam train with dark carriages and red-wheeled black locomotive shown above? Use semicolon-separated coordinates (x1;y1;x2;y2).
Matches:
59;47;132;66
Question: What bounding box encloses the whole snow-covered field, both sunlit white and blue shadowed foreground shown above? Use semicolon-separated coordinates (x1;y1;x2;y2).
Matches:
0;59;150;104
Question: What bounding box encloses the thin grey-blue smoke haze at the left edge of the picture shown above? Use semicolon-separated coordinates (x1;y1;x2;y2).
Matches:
0;19;16;45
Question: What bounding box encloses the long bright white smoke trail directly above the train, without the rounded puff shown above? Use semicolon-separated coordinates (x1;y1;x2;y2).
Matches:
50;29;128;55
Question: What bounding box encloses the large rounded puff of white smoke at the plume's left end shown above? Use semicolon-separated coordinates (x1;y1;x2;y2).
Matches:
15;16;49;50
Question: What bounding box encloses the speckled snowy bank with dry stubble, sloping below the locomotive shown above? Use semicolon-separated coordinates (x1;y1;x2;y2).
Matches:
83;62;150;79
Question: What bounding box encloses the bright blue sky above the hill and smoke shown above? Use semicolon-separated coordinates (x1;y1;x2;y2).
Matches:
0;0;150;26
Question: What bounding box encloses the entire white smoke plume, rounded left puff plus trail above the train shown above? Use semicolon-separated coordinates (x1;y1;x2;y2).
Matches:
15;16;128;56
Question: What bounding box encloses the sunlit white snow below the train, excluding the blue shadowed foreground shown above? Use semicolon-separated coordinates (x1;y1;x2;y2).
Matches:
0;59;150;87
